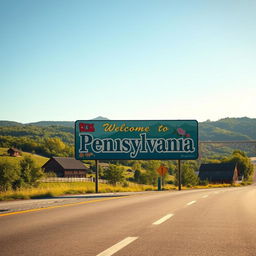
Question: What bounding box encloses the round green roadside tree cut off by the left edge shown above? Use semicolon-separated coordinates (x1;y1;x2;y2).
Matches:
0;160;20;191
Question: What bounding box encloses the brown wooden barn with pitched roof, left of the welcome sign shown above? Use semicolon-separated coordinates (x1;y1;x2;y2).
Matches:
42;157;88;178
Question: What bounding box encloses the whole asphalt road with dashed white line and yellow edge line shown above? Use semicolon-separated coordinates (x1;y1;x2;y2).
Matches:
0;185;256;256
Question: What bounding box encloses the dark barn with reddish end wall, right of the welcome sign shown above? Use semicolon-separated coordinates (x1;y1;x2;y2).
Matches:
198;163;238;184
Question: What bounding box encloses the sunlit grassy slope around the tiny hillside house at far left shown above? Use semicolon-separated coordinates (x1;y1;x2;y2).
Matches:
0;148;49;167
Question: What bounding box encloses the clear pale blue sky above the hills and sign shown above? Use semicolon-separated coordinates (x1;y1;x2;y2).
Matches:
0;0;256;123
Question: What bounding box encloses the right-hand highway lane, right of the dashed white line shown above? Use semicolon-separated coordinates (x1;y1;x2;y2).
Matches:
116;186;256;256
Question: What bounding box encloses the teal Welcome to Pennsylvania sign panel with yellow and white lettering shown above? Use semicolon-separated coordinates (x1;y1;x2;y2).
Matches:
75;120;198;160
